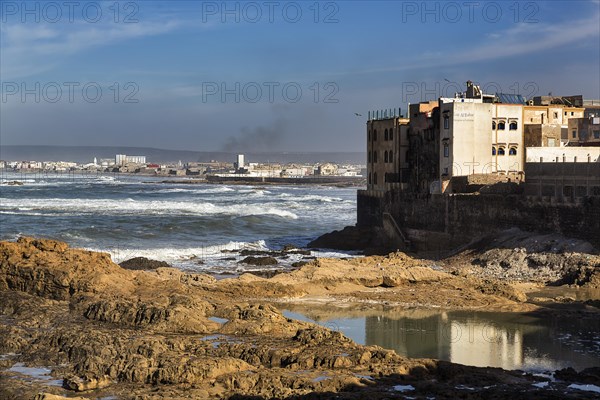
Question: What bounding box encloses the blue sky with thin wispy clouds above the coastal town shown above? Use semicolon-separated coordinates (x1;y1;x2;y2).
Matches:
0;0;600;152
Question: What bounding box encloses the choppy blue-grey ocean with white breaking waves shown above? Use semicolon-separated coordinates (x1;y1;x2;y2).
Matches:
0;172;357;274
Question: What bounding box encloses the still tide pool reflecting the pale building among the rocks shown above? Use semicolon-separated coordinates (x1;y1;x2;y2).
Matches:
286;311;600;371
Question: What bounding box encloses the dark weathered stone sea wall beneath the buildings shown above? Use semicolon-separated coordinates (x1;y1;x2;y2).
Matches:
358;192;600;247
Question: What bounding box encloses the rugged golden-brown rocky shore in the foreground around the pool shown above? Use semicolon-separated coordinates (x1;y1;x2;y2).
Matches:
0;238;600;400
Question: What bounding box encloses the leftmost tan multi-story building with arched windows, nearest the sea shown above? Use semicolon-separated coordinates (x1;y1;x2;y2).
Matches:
367;111;409;190
